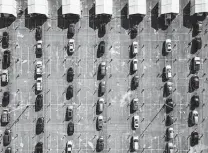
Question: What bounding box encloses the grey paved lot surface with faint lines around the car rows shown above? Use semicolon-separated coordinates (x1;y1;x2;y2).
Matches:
0;0;208;153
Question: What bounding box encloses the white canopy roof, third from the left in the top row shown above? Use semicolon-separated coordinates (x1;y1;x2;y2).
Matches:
62;0;81;15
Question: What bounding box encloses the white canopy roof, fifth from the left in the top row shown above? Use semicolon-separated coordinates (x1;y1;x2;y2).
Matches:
129;0;146;15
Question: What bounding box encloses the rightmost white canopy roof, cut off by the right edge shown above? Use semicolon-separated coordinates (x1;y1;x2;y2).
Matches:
191;0;208;15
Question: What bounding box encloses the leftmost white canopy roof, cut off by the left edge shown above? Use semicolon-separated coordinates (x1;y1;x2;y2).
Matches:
0;0;17;17
